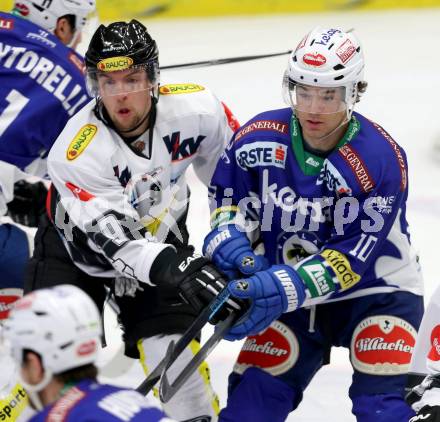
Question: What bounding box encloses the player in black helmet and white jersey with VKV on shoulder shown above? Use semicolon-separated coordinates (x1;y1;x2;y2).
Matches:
27;20;241;421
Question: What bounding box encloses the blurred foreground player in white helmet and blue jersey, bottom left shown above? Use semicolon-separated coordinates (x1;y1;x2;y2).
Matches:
3;285;177;422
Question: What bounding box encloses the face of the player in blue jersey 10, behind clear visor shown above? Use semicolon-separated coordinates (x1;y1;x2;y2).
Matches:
295;86;347;150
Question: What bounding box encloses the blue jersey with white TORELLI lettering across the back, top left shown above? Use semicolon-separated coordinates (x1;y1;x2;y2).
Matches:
0;12;90;177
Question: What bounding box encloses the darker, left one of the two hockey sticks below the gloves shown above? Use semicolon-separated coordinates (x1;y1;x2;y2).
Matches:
136;289;234;396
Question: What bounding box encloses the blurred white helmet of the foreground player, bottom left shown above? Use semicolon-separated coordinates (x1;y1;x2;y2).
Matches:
3;285;101;377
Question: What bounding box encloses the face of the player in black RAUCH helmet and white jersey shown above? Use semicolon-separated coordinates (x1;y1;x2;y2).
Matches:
98;69;153;135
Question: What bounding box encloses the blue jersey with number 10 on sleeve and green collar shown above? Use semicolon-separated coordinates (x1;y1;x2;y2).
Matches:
210;108;423;305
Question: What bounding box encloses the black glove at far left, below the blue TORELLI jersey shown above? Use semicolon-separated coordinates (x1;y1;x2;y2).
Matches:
8;180;47;227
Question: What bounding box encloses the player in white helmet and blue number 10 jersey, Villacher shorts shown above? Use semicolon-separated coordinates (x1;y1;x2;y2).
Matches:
204;28;423;422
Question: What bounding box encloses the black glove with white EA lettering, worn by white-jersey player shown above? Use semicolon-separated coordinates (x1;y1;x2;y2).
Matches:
150;247;247;324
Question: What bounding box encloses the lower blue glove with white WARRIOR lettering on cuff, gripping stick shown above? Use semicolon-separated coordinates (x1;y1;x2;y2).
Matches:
225;265;306;340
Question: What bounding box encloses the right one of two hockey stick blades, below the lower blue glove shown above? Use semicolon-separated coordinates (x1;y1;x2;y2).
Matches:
159;312;237;403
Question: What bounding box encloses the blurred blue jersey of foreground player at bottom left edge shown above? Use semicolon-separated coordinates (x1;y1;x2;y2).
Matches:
29;380;172;422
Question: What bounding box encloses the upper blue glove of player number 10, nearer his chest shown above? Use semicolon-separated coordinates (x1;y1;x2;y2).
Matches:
203;225;269;279
